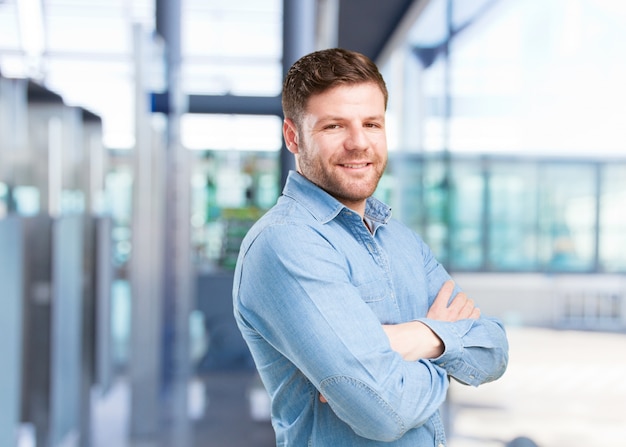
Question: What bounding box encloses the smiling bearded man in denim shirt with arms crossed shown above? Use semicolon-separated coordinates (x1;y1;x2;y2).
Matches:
233;49;508;447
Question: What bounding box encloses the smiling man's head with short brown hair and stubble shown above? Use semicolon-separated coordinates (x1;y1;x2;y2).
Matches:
283;49;387;215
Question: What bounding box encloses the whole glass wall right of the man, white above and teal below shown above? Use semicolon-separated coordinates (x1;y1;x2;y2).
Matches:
380;0;626;273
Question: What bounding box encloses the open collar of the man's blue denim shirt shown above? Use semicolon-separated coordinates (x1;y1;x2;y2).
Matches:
283;171;391;227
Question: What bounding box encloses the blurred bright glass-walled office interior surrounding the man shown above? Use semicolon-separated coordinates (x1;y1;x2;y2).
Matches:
0;0;626;447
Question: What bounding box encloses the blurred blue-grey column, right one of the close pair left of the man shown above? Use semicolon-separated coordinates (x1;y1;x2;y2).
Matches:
156;0;195;440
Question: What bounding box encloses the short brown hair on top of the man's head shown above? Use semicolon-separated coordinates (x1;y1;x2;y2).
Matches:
282;48;389;123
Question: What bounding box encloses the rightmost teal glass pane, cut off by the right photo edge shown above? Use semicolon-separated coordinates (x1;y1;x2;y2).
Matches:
599;164;626;272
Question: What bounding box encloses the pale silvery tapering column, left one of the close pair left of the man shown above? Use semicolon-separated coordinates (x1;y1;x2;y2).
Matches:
129;25;163;438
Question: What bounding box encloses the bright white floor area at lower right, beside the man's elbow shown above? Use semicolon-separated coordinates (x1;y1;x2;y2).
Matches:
449;328;626;447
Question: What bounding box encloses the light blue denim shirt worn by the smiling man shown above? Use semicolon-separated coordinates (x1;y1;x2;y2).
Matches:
233;172;508;447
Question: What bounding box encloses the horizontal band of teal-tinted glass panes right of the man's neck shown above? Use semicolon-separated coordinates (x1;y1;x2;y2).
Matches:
384;153;626;272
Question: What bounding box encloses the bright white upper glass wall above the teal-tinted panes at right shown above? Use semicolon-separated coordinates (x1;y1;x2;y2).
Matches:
384;0;626;156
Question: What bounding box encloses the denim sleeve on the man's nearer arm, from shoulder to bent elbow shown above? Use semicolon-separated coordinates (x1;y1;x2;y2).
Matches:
236;225;448;441
